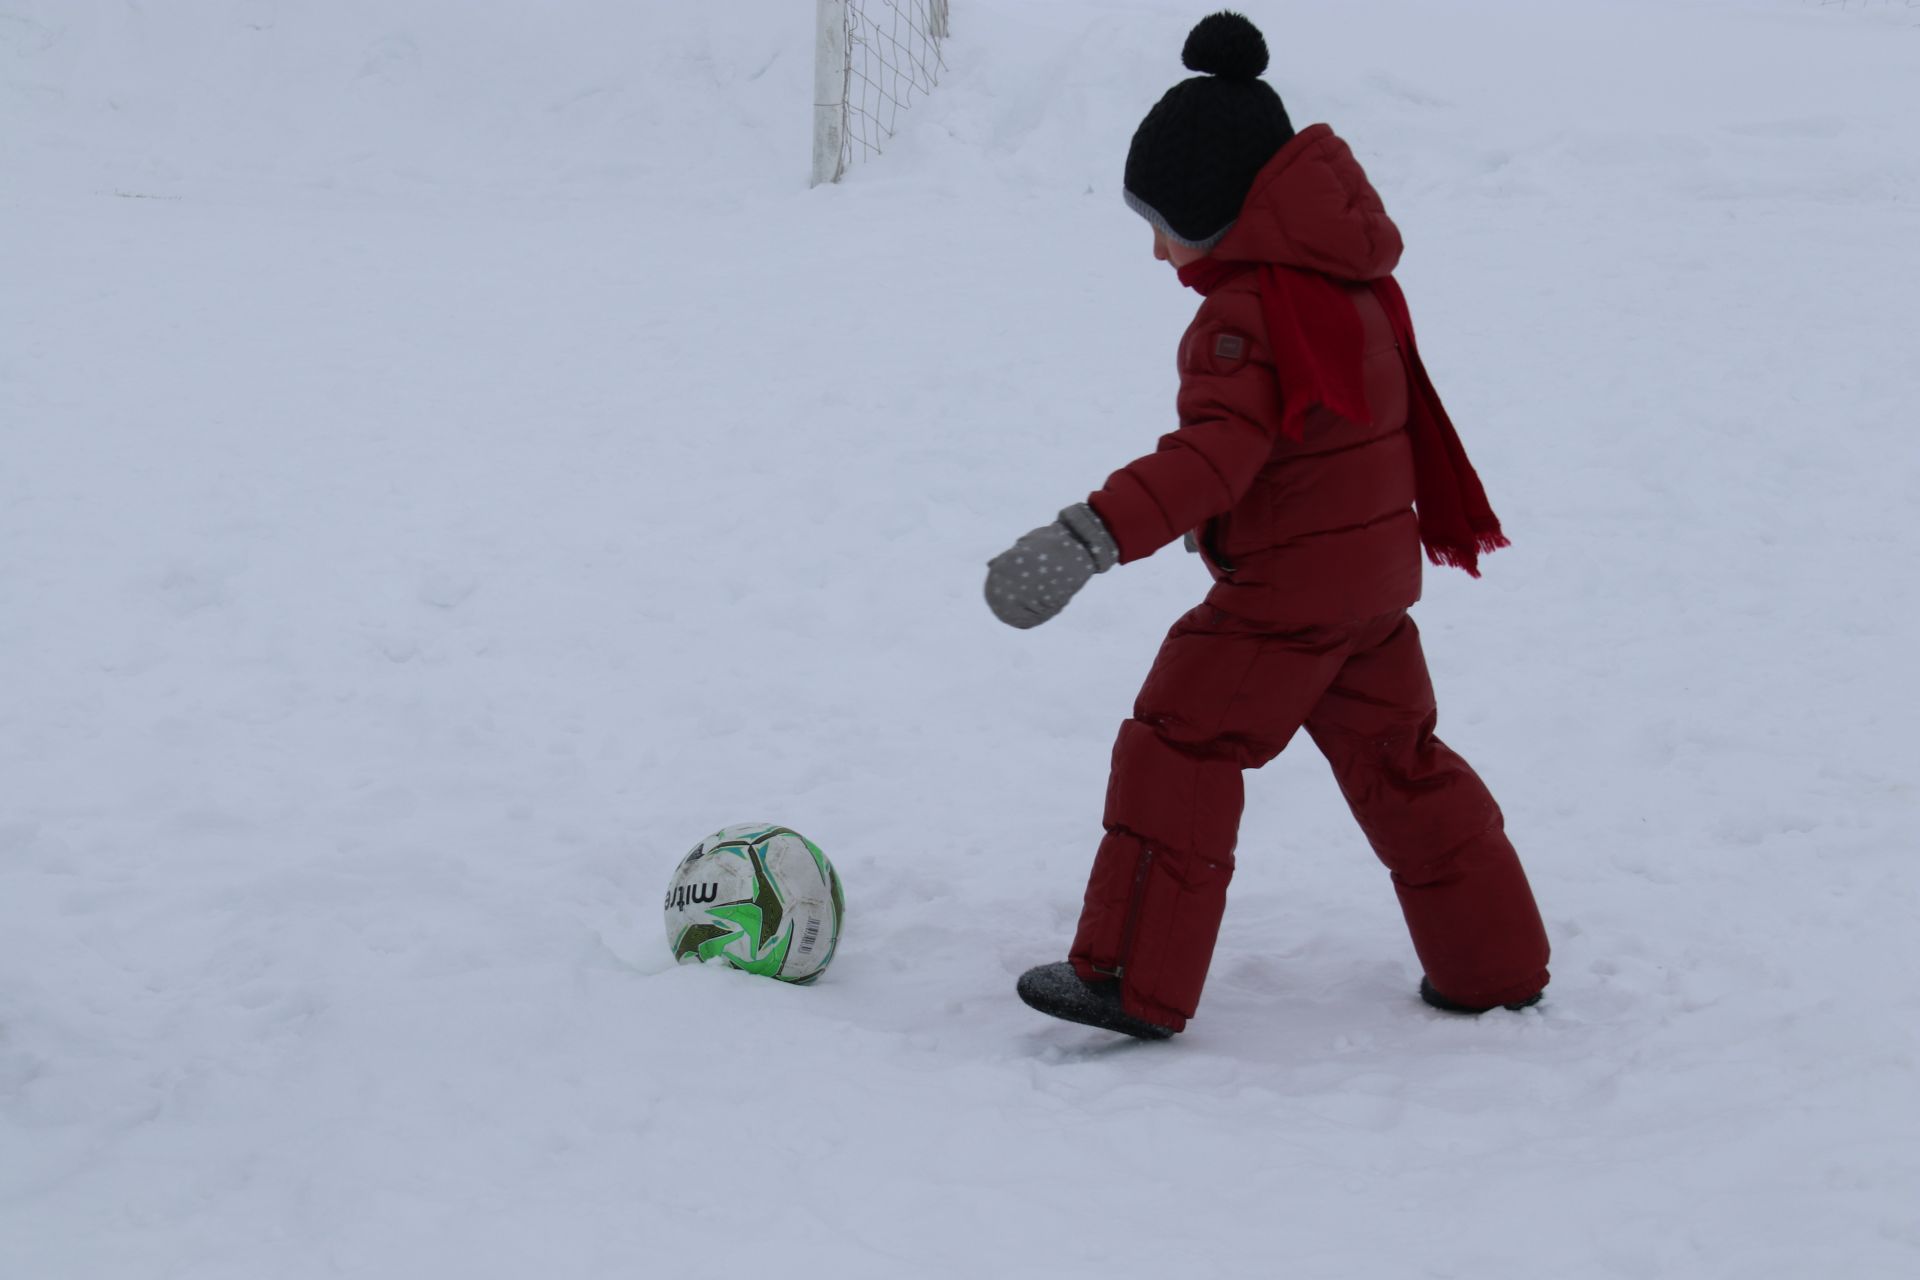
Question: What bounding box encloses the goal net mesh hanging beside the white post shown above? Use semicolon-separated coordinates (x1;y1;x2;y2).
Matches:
839;0;947;173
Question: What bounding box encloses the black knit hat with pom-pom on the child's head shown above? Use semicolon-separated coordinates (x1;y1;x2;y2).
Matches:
1127;12;1294;249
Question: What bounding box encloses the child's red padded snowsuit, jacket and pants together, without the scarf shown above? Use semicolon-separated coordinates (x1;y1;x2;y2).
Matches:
1071;125;1548;1029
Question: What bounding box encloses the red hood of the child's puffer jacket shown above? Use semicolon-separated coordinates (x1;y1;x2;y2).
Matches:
1213;125;1402;280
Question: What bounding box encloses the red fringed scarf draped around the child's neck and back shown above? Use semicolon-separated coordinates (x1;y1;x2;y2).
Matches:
1181;257;1507;578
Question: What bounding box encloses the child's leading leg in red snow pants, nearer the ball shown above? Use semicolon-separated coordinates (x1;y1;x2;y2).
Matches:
1071;606;1352;1029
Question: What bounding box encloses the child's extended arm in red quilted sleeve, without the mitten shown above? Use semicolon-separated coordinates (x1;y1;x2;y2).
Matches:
1087;290;1281;564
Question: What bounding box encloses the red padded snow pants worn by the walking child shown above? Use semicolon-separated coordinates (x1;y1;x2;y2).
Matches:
1071;604;1548;1029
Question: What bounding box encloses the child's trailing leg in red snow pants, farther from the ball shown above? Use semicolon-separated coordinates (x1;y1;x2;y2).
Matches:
1308;618;1548;1006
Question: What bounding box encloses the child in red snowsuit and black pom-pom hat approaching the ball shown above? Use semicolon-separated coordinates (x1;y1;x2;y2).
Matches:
987;13;1548;1038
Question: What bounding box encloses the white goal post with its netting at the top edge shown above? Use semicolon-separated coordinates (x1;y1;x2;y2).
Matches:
814;0;947;186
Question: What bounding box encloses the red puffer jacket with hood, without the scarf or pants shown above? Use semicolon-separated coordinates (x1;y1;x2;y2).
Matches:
1089;125;1421;629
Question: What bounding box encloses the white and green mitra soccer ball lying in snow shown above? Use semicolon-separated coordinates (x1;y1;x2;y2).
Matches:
666;823;847;983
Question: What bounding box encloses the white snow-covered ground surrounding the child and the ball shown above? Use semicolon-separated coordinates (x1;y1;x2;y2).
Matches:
0;0;1920;1280
